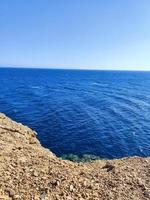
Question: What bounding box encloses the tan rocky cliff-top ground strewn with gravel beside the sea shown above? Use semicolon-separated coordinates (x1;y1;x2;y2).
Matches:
0;114;150;200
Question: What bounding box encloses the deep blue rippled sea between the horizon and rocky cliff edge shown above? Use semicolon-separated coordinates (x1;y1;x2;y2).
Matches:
0;68;150;158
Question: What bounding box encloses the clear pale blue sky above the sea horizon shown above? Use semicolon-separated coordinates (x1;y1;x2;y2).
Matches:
0;0;150;70
